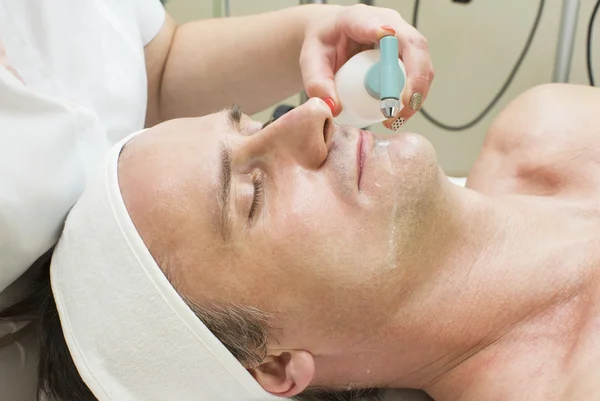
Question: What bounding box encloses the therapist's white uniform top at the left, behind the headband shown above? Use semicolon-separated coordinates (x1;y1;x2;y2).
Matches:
0;0;165;401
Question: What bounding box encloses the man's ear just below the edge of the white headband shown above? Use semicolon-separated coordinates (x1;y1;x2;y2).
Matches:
250;350;315;398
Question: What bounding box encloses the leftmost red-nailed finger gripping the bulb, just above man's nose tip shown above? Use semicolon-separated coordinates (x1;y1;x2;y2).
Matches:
299;38;342;117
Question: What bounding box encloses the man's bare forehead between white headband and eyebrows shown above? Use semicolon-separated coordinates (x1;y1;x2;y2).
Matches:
119;113;233;274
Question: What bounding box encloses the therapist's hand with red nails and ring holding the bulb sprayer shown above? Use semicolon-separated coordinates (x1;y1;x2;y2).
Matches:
300;4;434;130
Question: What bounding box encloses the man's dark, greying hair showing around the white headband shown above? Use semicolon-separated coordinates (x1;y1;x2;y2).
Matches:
0;252;379;401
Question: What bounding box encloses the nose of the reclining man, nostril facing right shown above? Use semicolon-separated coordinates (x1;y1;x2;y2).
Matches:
241;98;334;169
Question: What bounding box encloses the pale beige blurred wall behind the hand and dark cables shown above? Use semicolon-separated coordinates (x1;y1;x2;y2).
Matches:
159;0;600;176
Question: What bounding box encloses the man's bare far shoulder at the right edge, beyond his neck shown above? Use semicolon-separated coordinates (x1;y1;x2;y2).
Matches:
468;84;600;195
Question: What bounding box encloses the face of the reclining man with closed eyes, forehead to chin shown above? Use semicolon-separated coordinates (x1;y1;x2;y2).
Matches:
119;99;440;352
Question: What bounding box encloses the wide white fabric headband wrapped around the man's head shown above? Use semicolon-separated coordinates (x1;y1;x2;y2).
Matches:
50;134;282;401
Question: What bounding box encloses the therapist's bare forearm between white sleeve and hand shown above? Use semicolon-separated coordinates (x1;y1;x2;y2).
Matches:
152;6;326;121
